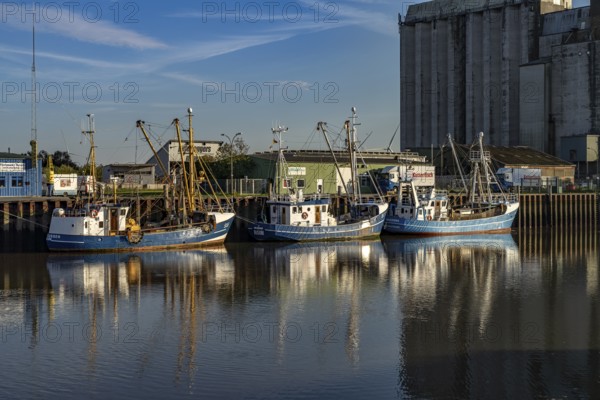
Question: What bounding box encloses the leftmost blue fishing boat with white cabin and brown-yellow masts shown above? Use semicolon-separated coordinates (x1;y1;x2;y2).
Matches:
46;108;235;252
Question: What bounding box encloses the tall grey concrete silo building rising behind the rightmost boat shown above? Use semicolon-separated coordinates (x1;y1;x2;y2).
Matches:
399;0;600;173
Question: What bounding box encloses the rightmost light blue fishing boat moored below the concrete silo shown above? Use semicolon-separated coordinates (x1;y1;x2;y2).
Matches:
384;133;519;235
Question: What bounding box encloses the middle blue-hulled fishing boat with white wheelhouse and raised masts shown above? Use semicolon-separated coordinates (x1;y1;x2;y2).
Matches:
247;107;388;242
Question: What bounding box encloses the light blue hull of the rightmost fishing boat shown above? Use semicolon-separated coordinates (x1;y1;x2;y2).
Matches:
383;208;518;236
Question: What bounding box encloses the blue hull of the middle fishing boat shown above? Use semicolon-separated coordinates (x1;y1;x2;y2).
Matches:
248;213;385;242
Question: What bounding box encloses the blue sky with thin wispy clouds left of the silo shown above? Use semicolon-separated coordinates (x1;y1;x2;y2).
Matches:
0;0;589;165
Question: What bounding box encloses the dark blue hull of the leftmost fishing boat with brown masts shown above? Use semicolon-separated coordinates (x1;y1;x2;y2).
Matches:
46;214;235;252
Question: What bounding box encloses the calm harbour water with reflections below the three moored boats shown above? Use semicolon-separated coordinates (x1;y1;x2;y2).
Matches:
0;225;600;399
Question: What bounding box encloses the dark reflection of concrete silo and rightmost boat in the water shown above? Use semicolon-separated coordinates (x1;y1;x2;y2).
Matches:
386;233;600;399
